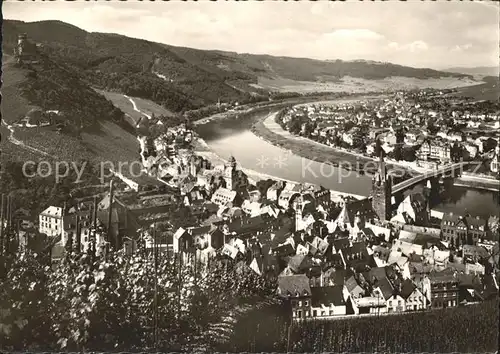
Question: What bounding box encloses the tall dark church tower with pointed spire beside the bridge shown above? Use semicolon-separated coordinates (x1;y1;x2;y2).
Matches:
372;155;392;221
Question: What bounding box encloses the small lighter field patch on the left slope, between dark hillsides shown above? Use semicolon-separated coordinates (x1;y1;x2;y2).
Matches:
96;90;175;124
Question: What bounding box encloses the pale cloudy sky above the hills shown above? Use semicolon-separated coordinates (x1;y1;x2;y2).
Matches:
3;0;500;69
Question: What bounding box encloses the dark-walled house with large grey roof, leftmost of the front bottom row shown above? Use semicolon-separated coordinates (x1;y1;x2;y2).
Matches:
278;274;311;319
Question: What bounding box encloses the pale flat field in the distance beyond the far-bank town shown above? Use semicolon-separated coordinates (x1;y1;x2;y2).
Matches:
252;76;477;93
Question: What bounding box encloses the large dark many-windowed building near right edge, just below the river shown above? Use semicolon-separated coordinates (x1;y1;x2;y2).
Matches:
441;213;486;247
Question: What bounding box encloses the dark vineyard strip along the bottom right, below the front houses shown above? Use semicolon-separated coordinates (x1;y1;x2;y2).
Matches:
228;299;499;353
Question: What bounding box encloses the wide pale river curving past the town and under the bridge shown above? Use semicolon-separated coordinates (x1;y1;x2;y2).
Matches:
197;109;500;218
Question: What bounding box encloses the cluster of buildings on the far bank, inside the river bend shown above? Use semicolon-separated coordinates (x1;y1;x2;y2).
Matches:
278;92;500;173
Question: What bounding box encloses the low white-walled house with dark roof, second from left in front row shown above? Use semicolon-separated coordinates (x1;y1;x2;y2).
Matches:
311;285;347;319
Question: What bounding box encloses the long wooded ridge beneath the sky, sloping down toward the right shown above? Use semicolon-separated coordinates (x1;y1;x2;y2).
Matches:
3;20;475;112
